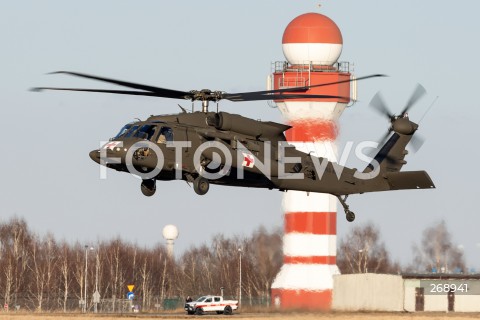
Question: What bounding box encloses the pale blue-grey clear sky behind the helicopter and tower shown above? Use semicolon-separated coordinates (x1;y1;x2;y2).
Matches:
0;0;480;269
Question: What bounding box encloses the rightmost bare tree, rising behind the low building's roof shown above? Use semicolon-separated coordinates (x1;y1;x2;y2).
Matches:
410;220;465;273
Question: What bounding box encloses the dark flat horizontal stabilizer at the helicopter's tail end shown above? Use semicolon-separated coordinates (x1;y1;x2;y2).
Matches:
386;171;435;190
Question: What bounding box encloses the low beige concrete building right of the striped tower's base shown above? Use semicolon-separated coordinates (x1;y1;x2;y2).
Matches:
332;273;480;312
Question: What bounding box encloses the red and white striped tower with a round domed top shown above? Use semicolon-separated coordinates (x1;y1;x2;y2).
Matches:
271;13;351;310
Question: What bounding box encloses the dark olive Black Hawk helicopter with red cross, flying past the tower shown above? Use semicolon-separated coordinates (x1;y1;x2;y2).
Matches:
33;71;435;221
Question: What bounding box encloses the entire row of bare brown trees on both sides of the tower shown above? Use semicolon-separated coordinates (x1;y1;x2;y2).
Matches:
0;218;465;312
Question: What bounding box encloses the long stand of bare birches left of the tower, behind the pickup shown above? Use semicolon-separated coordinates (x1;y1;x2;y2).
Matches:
0;218;282;311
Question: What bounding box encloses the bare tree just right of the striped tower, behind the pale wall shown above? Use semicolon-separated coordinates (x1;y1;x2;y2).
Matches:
337;223;400;273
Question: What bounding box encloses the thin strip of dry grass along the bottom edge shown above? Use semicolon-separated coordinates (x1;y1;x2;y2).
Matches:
0;312;480;320
